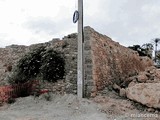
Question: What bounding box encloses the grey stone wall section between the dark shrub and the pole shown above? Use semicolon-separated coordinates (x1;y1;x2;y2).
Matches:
50;34;78;94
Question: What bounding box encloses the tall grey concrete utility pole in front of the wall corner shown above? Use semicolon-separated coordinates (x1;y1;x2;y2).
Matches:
77;0;84;98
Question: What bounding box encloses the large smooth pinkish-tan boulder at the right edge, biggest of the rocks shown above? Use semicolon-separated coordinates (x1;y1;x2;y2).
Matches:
126;83;160;109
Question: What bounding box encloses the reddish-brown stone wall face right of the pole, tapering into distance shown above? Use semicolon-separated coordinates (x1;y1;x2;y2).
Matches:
84;27;153;96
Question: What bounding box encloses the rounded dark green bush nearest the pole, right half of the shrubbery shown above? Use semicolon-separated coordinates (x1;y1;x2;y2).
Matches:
40;49;65;82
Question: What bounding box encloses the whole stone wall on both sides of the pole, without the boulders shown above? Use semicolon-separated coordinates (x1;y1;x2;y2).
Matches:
0;27;152;96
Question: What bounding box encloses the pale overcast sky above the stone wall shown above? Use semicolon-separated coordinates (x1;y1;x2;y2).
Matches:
0;0;160;47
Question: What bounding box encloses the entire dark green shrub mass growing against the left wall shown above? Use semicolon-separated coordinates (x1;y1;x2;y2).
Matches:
9;46;65;83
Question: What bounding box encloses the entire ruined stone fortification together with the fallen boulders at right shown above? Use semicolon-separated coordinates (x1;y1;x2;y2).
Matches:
0;27;160;108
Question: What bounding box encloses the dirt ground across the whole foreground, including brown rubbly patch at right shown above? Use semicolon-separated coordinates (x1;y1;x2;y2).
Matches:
0;92;160;120
